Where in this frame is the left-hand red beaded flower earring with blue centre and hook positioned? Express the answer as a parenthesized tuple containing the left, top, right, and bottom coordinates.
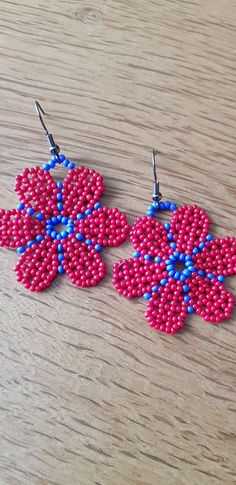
(0, 101, 129, 291)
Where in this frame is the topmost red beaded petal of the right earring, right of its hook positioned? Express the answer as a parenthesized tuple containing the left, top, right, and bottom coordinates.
(170, 205, 210, 253)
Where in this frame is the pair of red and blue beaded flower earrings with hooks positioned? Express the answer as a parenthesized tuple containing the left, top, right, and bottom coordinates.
(0, 101, 236, 334)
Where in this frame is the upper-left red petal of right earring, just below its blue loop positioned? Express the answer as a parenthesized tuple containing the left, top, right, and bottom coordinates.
(130, 216, 170, 257)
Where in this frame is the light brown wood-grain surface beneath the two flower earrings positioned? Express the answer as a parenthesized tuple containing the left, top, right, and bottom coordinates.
(0, 0, 236, 485)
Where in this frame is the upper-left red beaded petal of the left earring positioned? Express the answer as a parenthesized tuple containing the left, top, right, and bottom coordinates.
(15, 167, 58, 215)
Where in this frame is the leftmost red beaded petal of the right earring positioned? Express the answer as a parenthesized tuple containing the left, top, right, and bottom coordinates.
(112, 257, 164, 298)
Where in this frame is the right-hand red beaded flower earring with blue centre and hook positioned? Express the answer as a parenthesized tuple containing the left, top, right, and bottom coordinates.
(113, 151, 236, 334)
